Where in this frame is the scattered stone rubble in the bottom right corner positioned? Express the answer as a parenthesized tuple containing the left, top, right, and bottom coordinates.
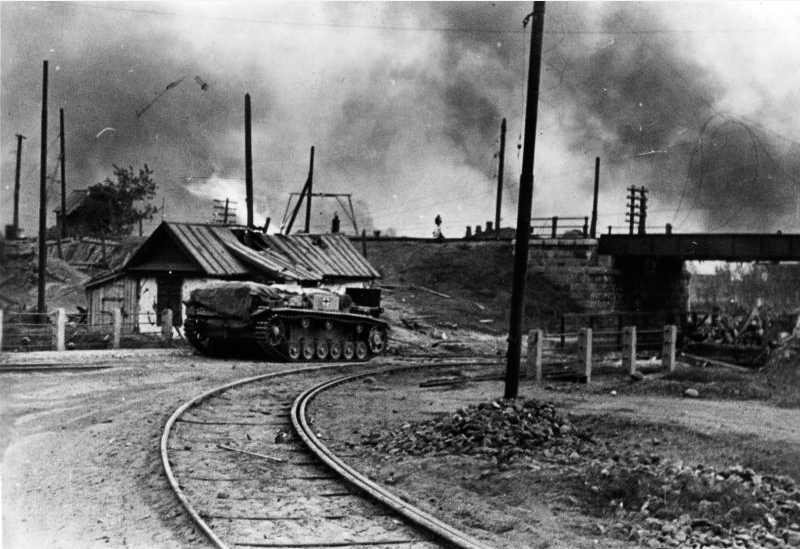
(579, 453, 800, 549)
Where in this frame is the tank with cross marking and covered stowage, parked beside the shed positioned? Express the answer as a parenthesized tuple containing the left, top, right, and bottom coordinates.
(184, 282, 389, 362)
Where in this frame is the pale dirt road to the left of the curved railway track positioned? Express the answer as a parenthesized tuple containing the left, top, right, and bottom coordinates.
(0, 350, 281, 549)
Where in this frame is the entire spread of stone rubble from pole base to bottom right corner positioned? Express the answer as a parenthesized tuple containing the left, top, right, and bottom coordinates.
(364, 400, 800, 549)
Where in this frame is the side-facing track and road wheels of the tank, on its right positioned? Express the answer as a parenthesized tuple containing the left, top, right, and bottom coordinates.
(255, 310, 387, 362)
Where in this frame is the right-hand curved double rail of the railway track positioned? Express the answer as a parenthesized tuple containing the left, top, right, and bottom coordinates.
(291, 364, 487, 549)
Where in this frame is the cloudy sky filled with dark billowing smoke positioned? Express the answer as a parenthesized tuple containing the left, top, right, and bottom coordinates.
(0, 2, 800, 237)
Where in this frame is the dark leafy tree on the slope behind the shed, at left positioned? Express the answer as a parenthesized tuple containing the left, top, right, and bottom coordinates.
(84, 164, 158, 237)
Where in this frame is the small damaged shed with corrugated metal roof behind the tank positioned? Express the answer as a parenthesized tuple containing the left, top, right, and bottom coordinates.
(86, 222, 380, 333)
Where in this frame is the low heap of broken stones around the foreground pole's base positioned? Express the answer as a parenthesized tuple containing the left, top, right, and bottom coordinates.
(364, 399, 588, 462)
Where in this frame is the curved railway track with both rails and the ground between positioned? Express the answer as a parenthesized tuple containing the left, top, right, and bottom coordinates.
(161, 362, 494, 549)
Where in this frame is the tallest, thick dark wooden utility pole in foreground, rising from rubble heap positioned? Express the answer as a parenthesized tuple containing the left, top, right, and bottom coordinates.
(505, 2, 545, 398)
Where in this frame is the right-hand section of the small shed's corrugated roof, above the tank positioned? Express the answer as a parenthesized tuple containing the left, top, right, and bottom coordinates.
(258, 234, 381, 279)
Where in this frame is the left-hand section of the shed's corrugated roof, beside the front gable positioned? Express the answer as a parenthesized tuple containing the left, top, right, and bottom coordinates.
(162, 222, 251, 276)
